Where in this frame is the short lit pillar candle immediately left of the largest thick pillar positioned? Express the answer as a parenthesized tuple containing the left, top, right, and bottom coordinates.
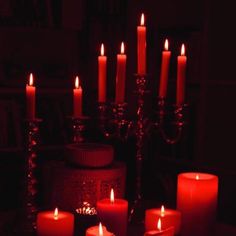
(145, 206, 181, 234)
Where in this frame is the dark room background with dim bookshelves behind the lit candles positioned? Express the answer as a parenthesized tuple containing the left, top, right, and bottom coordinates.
(0, 0, 236, 231)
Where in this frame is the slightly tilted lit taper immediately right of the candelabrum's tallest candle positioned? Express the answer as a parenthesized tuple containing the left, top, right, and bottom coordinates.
(159, 39, 171, 98)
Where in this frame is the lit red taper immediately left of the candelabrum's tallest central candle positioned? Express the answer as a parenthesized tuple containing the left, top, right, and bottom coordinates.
(115, 42, 126, 103)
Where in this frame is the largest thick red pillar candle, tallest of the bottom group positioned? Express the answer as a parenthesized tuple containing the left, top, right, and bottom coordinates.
(177, 172, 218, 236)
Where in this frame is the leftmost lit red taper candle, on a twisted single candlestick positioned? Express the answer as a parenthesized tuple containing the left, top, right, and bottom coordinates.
(26, 73, 36, 119)
